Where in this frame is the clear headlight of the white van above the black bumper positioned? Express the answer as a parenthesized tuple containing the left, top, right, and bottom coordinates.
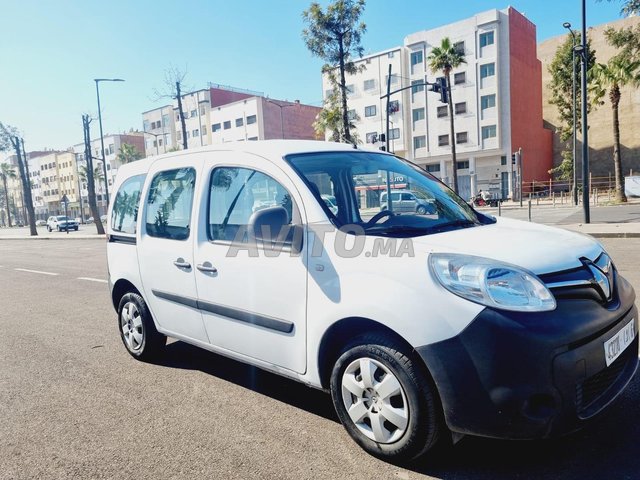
(429, 253, 556, 312)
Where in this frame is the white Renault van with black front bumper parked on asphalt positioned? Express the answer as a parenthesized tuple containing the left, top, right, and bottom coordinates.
(107, 141, 638, 460)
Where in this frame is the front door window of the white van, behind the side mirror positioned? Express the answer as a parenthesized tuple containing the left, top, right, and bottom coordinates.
(207, 167, 297, 242)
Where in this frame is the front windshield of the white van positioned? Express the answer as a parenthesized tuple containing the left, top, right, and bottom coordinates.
(286, 151, 495, 236)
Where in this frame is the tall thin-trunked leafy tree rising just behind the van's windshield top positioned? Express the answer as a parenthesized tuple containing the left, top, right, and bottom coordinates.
(302, 0, 367, 143)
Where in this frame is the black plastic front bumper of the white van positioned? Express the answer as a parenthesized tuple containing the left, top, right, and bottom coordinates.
(416, 274, 638, 439)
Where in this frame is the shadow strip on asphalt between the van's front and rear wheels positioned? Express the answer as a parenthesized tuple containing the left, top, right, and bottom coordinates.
(153, 341, 339, 422)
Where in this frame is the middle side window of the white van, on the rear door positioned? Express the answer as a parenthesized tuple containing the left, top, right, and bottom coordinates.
(145, 168, 196, 240)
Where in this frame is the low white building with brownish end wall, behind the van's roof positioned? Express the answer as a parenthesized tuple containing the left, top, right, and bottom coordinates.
(142, 84, 321, 156)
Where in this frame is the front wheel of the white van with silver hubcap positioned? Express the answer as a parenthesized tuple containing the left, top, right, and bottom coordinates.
(330, 335, 446, 462)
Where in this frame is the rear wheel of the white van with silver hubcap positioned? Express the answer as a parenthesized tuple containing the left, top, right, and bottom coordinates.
(118, 293, 167, 361)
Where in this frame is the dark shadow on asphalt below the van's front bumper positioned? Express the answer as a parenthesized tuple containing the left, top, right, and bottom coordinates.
(416, 368, 640, 480)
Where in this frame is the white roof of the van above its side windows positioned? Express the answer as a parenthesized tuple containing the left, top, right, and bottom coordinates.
(118, 140, 384, 177)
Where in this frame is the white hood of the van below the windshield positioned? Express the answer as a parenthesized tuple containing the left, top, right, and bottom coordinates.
(413, 217, 604, 275)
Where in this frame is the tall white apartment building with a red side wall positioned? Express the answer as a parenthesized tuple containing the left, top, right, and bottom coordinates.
(323, 7, 552, 198)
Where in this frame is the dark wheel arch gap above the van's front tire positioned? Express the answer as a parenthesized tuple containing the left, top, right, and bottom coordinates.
(318, 317, 431, 389)
